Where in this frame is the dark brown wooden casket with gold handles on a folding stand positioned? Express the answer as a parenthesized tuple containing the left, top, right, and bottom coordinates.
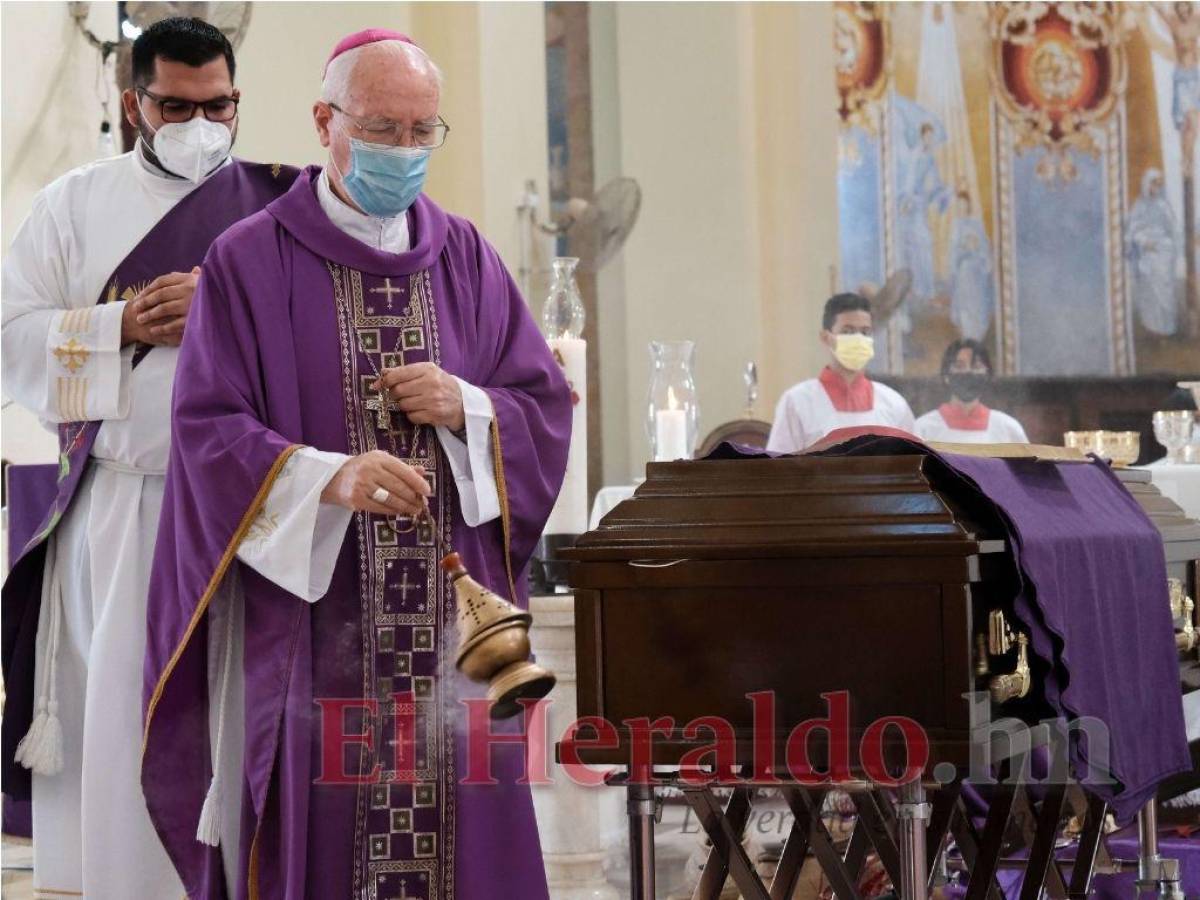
(564, 454, 1200, 776)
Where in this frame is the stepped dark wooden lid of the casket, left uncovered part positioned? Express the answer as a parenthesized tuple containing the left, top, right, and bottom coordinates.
(562, 452, 1004, 562)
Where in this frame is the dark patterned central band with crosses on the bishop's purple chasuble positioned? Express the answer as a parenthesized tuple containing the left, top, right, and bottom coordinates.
(319, 263, 457, 900)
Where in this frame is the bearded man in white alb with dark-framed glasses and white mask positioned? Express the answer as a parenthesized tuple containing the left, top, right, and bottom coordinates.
(2, 18, 295, 900)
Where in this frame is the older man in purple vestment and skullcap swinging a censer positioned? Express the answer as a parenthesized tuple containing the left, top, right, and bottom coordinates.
(142, 30, 571, 900)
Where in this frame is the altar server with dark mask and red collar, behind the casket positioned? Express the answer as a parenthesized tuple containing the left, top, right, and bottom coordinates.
(917, 338, 1030, 444)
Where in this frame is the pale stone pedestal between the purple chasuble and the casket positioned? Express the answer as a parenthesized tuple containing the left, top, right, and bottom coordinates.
(529, 594, 618, 900)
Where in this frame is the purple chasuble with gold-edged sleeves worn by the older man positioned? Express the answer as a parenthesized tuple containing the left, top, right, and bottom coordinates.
(142, 167, 571, 900)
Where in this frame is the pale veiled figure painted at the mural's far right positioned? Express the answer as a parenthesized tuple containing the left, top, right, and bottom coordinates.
(1126, 169, 1178, 335)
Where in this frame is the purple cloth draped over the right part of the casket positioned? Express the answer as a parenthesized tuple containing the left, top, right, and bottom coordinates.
(709, 434, 1192, 822)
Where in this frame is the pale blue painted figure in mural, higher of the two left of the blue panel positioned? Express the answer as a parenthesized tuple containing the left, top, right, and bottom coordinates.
(896, 120, 949, 321)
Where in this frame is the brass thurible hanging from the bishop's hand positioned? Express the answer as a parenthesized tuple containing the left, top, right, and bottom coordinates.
(442, 553, 556, 719)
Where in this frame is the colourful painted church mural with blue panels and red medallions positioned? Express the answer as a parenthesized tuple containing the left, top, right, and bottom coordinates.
(833, 2, 1200, 376)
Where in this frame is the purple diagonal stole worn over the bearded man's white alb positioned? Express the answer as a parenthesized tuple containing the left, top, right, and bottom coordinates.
(0, 160, 299, 798)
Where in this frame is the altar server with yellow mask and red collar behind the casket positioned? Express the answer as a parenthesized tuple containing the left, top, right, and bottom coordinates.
(767, 294, 913, 452)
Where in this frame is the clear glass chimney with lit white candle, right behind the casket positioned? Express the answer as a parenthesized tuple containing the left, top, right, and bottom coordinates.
(646, 341, 700, 462)
